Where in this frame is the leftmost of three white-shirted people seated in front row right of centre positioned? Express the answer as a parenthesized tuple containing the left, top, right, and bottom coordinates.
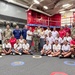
(41, 41, 51, 55)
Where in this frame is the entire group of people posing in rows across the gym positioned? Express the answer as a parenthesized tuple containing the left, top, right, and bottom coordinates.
(0, 23, 75, 57)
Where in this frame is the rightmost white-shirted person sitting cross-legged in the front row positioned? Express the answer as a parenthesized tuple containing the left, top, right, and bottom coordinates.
(62, 40, 71, 57)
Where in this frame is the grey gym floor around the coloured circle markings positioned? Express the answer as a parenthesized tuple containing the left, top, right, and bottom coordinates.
(0, 52, 75, 75)
